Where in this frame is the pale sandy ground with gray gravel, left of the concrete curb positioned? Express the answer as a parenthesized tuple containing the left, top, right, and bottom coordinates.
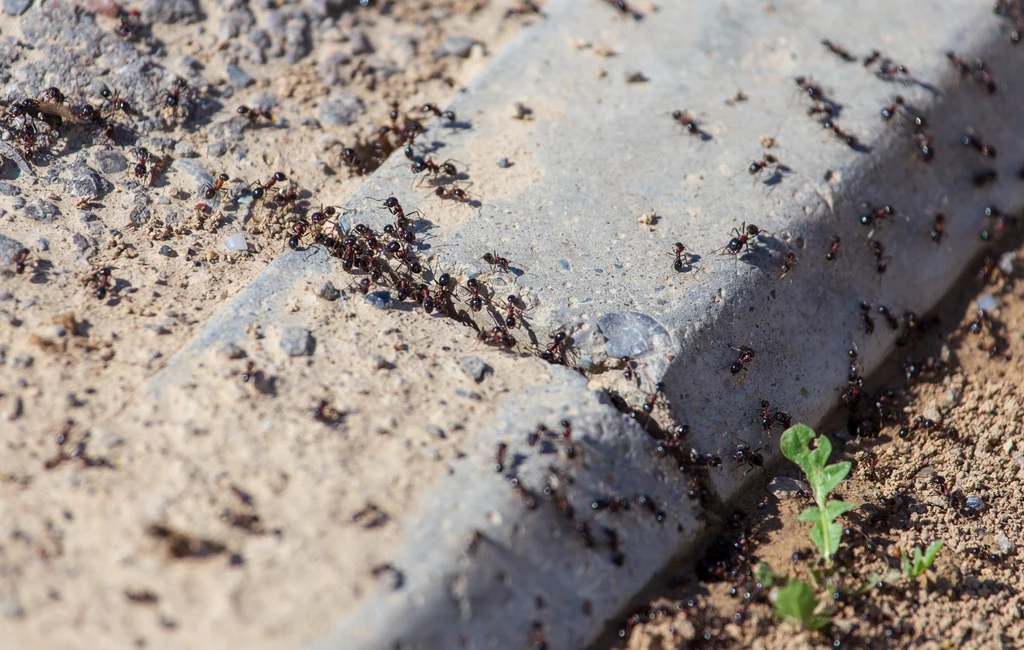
(0, 0, 545, 648)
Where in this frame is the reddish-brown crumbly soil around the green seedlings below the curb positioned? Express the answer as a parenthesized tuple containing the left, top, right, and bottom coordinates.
(597, 240, 1024, 650)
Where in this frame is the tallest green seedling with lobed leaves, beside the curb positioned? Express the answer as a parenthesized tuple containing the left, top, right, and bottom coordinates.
(781, 425, 855, 560)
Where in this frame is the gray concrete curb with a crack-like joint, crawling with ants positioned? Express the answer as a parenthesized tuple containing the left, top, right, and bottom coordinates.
(134, 0, 1024, 648)
